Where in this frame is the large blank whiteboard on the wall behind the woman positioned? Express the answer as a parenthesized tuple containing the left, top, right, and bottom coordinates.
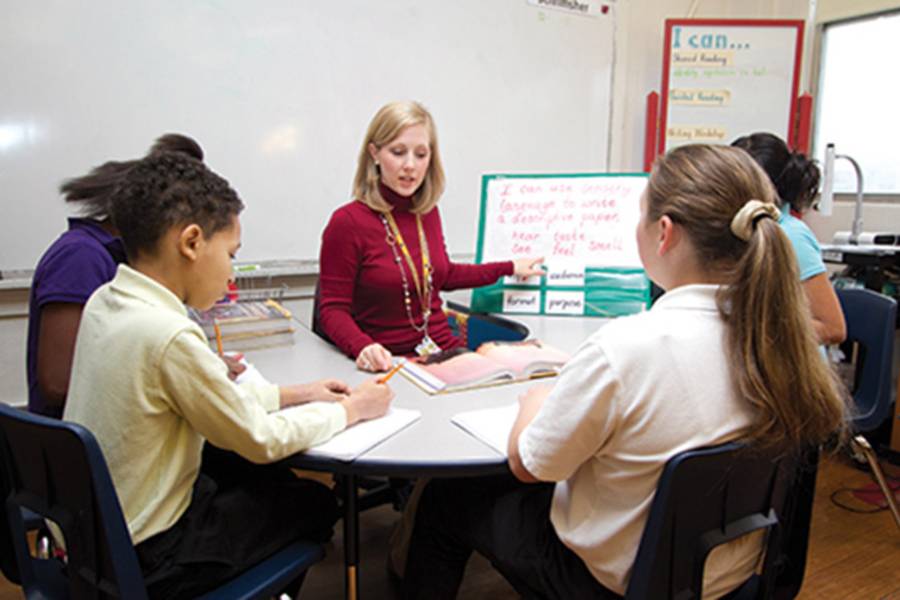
(0, 0, 615, 269)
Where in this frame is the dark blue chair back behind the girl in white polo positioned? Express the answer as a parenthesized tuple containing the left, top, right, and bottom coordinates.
(625, 443, 815, 600)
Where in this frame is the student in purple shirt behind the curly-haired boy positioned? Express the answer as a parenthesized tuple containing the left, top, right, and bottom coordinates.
(26, 134, 203, 418)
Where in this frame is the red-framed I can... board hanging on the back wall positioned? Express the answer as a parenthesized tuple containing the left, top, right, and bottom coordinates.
(659, 19, 803, 153)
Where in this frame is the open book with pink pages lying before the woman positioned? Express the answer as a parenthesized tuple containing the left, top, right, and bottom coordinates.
(400, 340, 569, 394)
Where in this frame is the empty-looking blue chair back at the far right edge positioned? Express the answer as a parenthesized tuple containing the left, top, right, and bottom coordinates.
(837, 289, 897, 431)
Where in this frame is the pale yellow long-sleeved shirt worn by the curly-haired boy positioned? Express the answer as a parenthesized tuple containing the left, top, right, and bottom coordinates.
(63, 265, 347, 544)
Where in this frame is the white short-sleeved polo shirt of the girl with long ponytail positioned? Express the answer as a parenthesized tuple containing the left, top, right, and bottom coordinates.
(519, 285, 762, 597)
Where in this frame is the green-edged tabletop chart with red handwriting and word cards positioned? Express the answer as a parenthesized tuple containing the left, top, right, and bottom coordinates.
(472, 173, 650, 317)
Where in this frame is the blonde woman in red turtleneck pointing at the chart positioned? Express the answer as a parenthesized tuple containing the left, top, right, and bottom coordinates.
(319, 101, 543, 371)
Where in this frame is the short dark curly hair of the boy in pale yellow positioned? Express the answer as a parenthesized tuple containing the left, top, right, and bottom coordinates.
(110, 152, 244, 260)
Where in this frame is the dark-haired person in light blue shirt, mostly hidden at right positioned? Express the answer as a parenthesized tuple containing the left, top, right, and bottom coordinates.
(731, 133, 847, 344)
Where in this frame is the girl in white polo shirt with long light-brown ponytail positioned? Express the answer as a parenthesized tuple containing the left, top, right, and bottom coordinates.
(404, 145, 846, 598)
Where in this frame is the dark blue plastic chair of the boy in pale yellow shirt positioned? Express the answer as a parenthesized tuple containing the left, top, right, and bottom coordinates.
(0, 404, 324, 600)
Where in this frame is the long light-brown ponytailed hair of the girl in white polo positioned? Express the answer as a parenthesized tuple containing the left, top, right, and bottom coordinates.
(647, 145, 848, 447)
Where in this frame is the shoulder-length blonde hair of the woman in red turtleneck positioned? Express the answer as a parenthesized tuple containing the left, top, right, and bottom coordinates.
(353, 100, 444, 214)
